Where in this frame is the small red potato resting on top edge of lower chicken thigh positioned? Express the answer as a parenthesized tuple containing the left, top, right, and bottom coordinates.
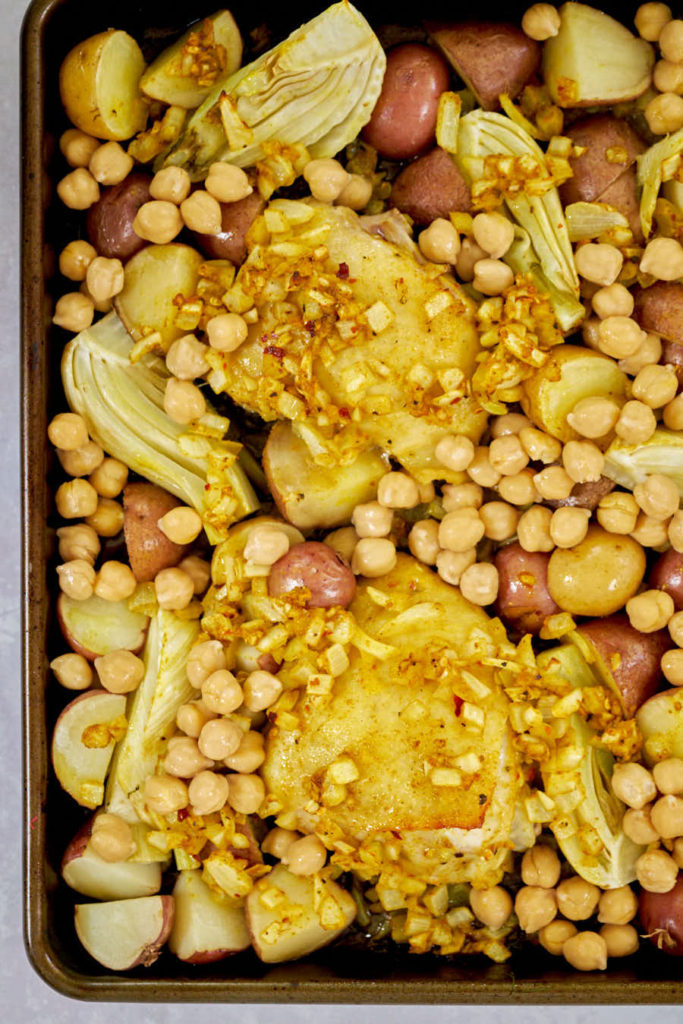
(268, 541, 355, 608)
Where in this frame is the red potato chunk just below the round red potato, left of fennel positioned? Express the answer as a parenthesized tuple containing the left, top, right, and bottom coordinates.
(391, 146, 472, 224)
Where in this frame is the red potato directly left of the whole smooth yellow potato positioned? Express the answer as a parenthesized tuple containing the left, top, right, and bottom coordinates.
(494, 541, 560, 633)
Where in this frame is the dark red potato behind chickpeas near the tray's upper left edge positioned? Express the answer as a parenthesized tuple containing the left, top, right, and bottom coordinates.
(87, 171, 152, 261)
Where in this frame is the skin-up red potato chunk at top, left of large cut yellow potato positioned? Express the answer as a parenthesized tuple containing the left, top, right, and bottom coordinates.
(426, 22, 541, 111)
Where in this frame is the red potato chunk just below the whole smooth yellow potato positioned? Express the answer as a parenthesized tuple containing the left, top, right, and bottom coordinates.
(578, 614, 671, 717)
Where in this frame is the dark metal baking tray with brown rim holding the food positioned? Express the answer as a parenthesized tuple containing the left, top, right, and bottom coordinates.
(22, 0, 683, 1004)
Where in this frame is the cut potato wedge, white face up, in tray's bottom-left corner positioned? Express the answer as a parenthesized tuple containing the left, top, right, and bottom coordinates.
(74, 896, 174, 971)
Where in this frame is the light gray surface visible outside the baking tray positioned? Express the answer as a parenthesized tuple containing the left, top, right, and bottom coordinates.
(0, 0, 683, 1024)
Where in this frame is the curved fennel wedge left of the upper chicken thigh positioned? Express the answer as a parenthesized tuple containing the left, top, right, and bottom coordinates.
(61, 312, 258, 544)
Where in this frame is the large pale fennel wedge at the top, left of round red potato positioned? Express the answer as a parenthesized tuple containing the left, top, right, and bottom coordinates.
(166, 0, 386, 180)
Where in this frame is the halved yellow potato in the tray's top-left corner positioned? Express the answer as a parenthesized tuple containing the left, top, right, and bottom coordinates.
(59, 29, 147, 139)
